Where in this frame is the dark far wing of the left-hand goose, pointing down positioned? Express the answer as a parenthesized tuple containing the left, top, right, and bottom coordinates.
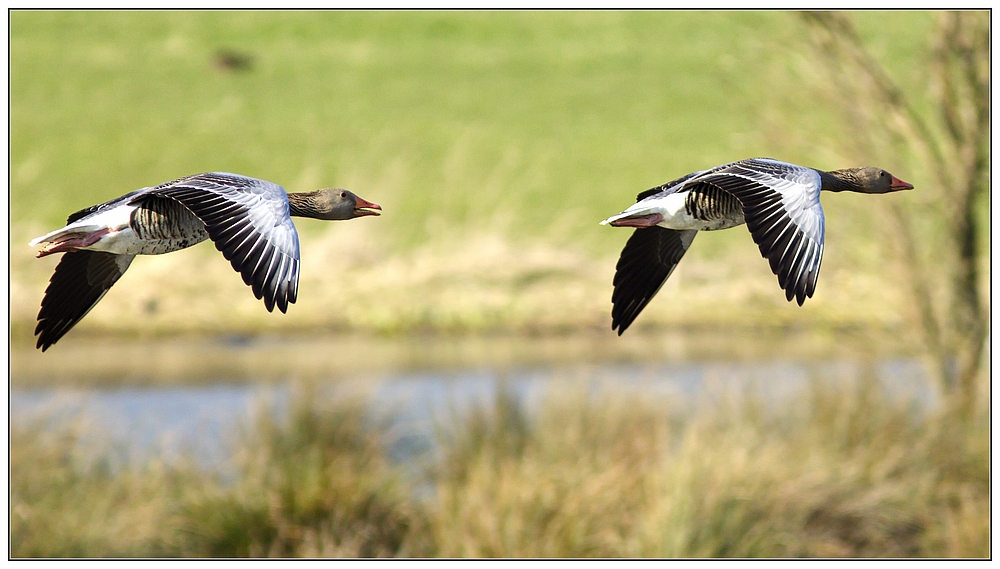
(35, 251, 135, 352)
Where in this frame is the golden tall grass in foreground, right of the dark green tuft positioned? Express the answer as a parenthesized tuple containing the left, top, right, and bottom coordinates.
(420, 374, 989, 557)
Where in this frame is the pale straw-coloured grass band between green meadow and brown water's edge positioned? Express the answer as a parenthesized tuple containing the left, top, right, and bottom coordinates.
(10, 220, 913, 353)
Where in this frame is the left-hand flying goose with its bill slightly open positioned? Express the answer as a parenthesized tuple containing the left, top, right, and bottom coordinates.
(29, 172, 382, 352)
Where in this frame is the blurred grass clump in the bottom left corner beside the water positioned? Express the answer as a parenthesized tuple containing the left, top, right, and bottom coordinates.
(10, 408, 197, 557)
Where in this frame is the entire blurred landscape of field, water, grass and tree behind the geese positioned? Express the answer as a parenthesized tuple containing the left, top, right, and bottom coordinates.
(9, 11, 990, 557)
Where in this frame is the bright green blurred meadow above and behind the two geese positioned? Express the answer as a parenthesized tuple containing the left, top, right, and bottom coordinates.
(11, 12, 930, 243)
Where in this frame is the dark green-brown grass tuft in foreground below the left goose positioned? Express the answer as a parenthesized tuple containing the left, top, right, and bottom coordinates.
(178, 388, 422, 557)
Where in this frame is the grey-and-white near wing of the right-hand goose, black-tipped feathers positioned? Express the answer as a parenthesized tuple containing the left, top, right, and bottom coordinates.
(698, 158, 825, 306)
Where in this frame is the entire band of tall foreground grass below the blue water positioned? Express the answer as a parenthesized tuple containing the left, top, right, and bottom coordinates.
(11, 374, 990, 557)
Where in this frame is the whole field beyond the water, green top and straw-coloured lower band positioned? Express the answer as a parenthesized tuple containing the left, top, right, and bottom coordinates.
(10, 12, 944, 343)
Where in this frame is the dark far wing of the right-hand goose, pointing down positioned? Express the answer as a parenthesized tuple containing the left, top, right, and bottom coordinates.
(611, 226, 698, 336)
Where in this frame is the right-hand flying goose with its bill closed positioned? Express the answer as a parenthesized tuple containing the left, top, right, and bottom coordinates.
(601, 158, 913, 336)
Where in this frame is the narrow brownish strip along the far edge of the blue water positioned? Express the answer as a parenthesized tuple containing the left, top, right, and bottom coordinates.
(10, 327, 917, 390)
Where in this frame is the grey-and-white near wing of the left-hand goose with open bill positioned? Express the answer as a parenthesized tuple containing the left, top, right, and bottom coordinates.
(149, 172, 299, 312)
